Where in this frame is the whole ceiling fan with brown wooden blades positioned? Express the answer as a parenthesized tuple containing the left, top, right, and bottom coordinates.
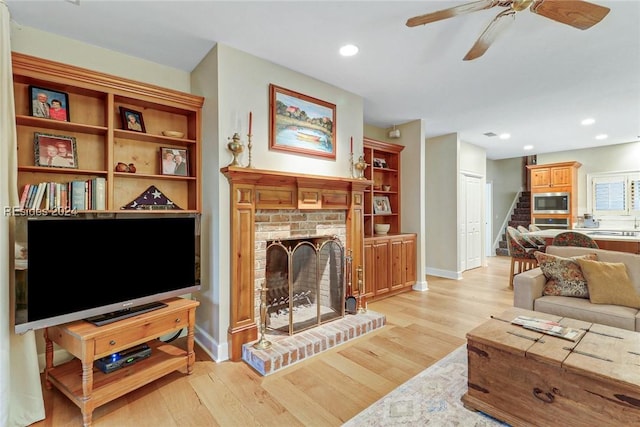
(407, 0, 610, 61)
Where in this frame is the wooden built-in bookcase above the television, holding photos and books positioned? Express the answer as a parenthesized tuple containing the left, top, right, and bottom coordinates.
(12, 52, 204, 213)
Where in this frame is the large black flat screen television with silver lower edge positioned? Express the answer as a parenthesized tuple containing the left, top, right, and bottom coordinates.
(14, 213, 200, 333)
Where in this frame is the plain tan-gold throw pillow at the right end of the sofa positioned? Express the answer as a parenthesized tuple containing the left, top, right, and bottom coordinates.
(577, 259, 640, 309)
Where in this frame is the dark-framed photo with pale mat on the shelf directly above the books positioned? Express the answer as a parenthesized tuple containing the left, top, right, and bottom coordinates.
(33, 132, 78, 169)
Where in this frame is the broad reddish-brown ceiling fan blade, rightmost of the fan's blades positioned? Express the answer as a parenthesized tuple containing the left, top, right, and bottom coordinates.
(529, 0, 610, 30)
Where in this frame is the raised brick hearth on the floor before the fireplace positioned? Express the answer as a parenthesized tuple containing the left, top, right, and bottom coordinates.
(242, 310, 386, 376)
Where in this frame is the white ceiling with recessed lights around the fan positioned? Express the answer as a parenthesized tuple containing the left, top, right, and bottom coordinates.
(5, 0, 640, 159)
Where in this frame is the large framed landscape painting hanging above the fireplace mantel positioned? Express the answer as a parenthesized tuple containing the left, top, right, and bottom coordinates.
(269, 84, 336, 160)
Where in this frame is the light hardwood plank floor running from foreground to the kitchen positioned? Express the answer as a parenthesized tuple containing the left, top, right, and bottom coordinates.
(33, 257, 513, 427)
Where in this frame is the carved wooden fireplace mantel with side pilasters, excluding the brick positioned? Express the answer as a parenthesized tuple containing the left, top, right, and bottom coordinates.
(220, 166, 372, 361)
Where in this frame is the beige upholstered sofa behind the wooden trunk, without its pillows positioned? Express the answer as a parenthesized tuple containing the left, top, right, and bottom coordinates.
(513, 246, 640, 332)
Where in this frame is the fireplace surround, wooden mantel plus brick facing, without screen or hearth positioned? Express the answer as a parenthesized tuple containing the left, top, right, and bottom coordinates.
(221, 166, 371, 361)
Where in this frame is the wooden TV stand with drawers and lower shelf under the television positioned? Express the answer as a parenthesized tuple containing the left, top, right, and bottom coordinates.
(44, 298, 200, 426)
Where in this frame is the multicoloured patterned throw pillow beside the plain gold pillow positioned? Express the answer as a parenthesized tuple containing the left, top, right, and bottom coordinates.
(534, 251, 598, 298)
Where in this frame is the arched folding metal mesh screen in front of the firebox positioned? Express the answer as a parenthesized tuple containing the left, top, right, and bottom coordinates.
(266, 236, 345, 335)
